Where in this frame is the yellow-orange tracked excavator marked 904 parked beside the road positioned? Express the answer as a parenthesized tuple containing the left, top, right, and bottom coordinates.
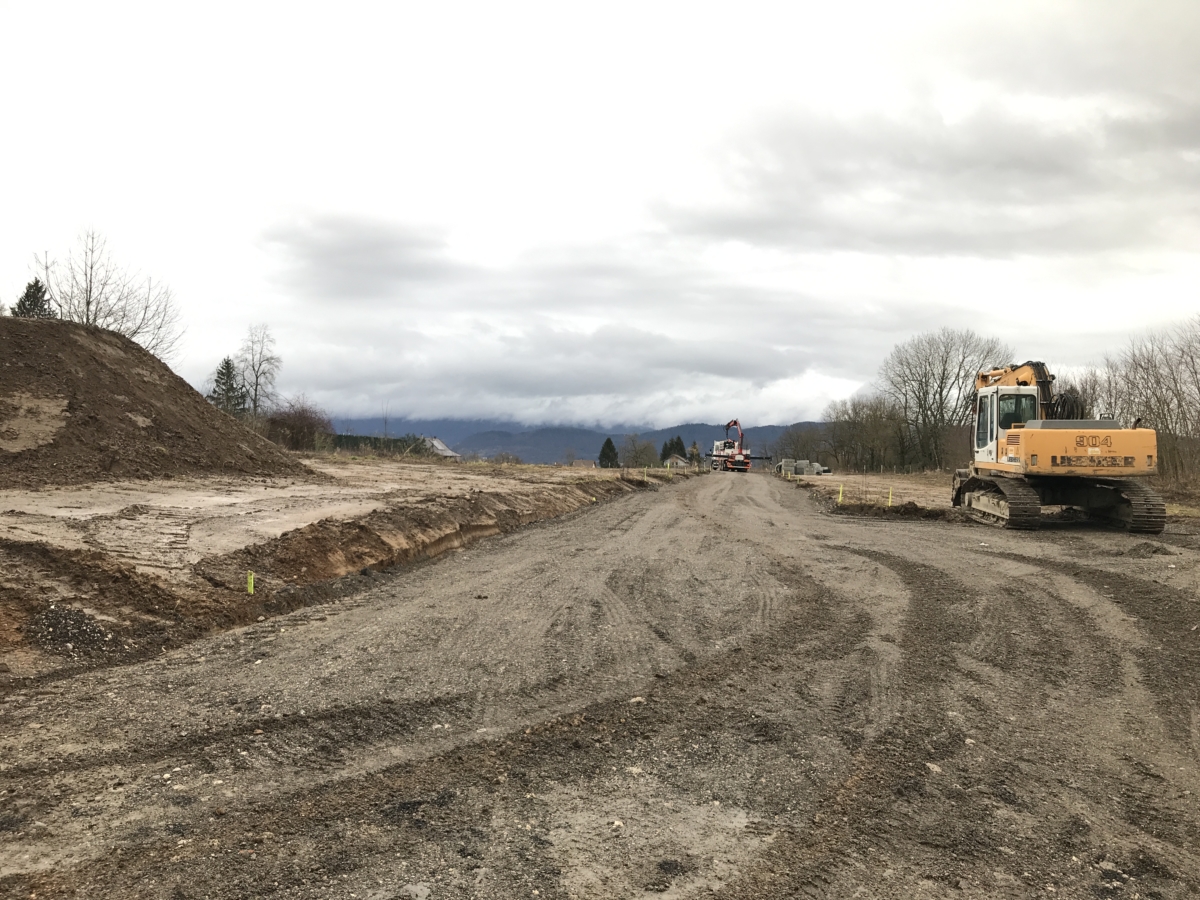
(954, 362, 1166, 534)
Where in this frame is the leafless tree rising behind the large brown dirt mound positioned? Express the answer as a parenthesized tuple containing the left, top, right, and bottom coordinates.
(37, 229, 184, 360)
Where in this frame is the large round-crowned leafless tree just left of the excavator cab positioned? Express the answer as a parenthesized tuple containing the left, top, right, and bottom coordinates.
(880, 328, 1013, 468)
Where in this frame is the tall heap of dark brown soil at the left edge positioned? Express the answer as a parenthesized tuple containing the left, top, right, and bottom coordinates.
(0, 317, 306, 488)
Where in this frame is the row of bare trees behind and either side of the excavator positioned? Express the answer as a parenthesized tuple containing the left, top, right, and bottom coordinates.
(773, 316, 1200, 480)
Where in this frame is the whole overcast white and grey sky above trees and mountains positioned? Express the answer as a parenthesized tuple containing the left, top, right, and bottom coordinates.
(0, 0, 1200, 426)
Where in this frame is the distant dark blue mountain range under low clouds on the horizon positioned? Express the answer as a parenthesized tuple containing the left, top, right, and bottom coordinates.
(334, 418, 815, 463)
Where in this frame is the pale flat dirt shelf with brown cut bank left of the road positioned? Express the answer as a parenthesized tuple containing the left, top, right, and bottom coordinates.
(0, 461, 681, 685)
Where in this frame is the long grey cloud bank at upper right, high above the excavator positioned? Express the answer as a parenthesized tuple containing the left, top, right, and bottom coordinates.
(664, 102, 1200, 257)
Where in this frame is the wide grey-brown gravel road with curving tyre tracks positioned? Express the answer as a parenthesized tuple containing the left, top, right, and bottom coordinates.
(0, 475, 1200, 900)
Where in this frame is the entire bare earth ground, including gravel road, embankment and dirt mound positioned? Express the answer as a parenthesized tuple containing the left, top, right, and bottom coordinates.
(0, 319, 1200, 900)
